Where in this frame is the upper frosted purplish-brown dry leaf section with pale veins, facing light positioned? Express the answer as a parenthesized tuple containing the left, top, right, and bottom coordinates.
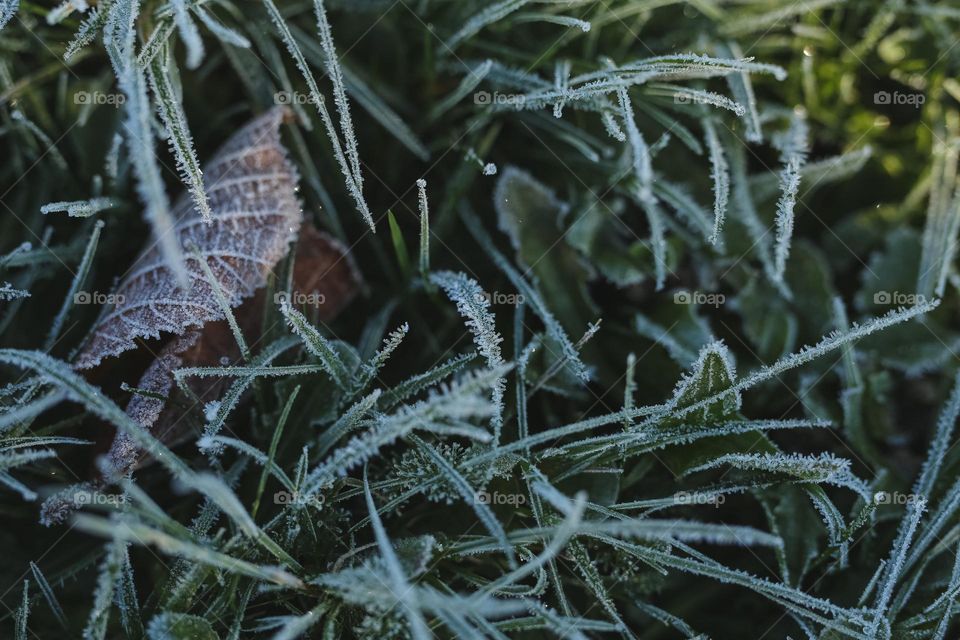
(76, 108, 303, 369)
